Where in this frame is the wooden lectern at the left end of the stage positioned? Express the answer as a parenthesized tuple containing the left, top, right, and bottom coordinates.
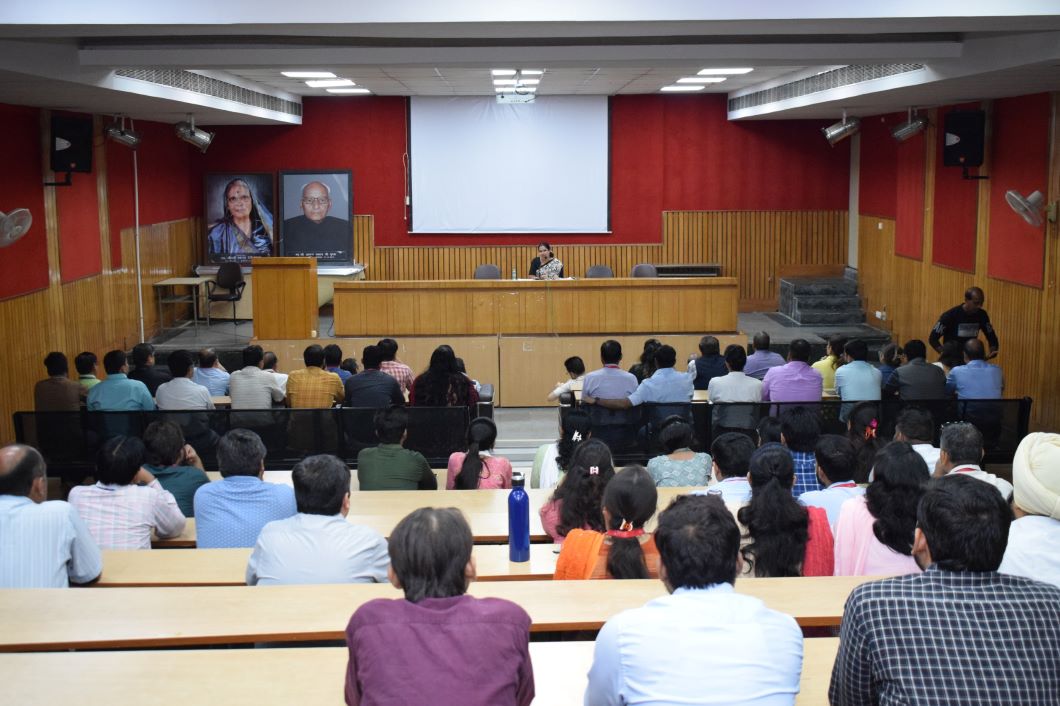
(250, 258, 318, 339)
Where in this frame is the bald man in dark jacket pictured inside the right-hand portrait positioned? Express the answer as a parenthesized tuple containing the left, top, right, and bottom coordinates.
(281, 181, 353, 262)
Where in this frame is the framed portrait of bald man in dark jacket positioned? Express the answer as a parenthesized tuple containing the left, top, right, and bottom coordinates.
(280, 170, 353, 263)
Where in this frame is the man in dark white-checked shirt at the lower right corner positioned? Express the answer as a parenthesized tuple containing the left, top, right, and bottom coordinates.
(826, 474, 1060, 706)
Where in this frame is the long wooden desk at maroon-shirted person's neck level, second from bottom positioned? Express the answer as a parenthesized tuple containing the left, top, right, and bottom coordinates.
(0, 577, 869, 652)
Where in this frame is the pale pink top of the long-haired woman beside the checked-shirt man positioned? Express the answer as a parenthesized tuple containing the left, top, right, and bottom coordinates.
(835, 495, 920, 576)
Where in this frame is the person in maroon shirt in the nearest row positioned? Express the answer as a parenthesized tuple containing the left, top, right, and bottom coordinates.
(346, 508, 534, 706)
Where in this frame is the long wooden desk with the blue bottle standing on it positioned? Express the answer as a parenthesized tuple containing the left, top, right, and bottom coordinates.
(102, 544, 558, 587)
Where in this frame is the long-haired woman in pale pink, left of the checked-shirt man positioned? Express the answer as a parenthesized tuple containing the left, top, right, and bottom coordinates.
(835, 441, 929, 576)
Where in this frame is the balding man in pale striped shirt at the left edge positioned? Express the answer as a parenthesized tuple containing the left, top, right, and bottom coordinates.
(0, 444, 103, 588)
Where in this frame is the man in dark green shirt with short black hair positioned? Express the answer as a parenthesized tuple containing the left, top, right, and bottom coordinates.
(357, 407, 438, 491)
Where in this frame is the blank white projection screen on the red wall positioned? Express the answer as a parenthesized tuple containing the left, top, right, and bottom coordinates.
(409, 95, 608, 233)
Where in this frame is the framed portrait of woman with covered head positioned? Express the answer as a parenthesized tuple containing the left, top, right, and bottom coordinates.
(202, 173, 276, 264)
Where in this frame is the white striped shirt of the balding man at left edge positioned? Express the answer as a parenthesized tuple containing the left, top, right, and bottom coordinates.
(0, 495, 103, 588)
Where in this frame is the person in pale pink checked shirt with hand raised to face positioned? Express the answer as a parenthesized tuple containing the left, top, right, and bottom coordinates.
(70, 434, 186, 549)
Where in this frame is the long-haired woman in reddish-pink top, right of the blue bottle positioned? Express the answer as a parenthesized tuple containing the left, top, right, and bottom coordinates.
(538, 439, 615, 544)
